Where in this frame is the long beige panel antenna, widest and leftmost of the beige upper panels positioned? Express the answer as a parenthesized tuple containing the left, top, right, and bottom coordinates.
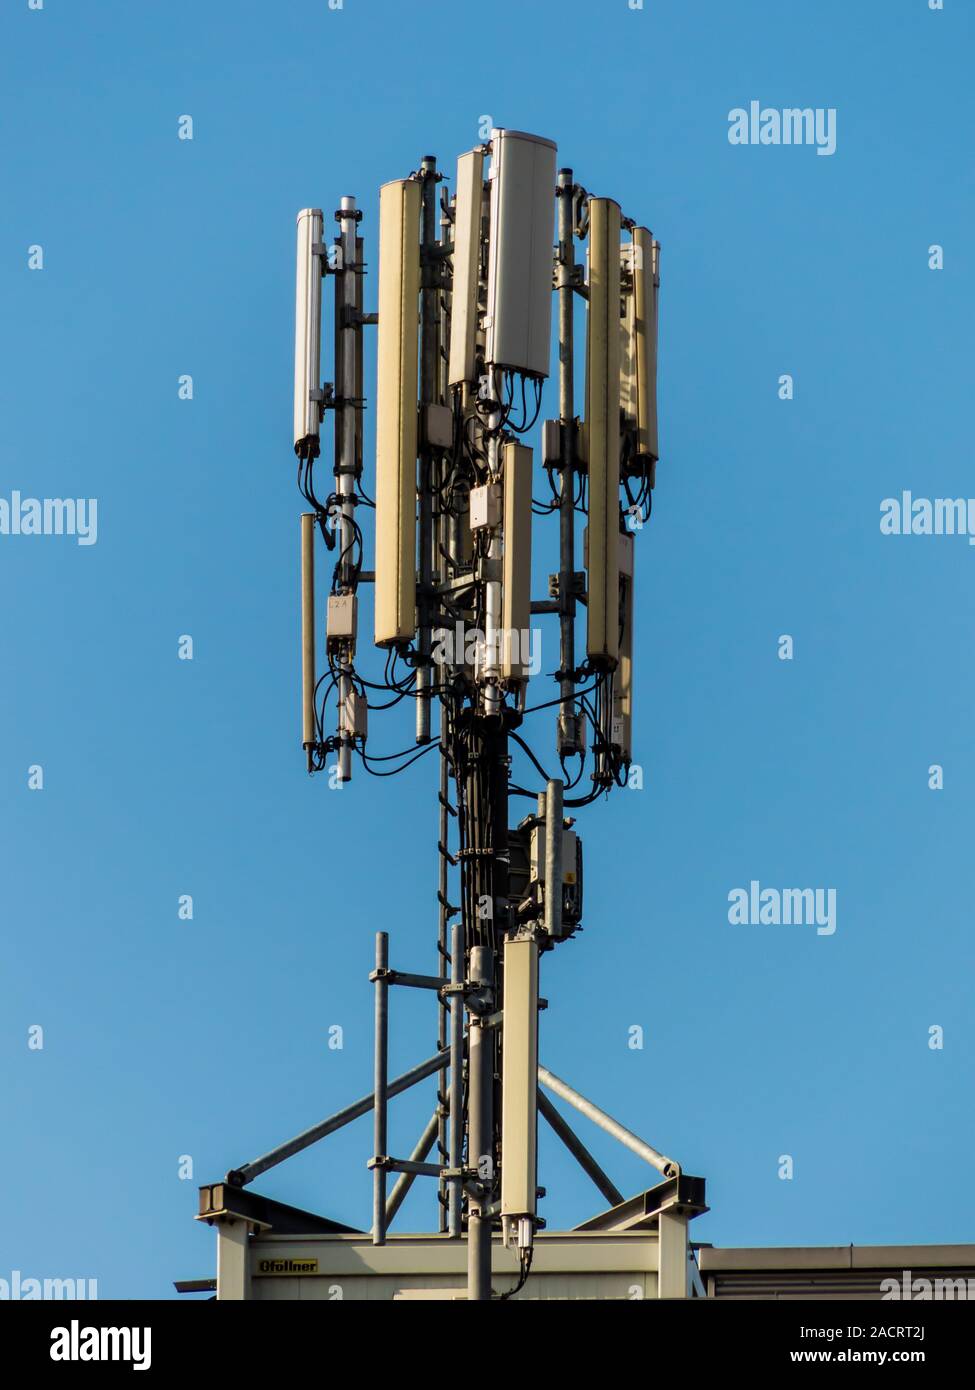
(376, 179, 420, 646)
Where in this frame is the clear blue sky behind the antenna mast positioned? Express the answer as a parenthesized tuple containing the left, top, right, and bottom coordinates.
(0, 0, 975, 1297)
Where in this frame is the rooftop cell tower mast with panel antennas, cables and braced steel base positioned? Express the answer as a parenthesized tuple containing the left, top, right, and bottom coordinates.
(200, 129, 705, 1300)
